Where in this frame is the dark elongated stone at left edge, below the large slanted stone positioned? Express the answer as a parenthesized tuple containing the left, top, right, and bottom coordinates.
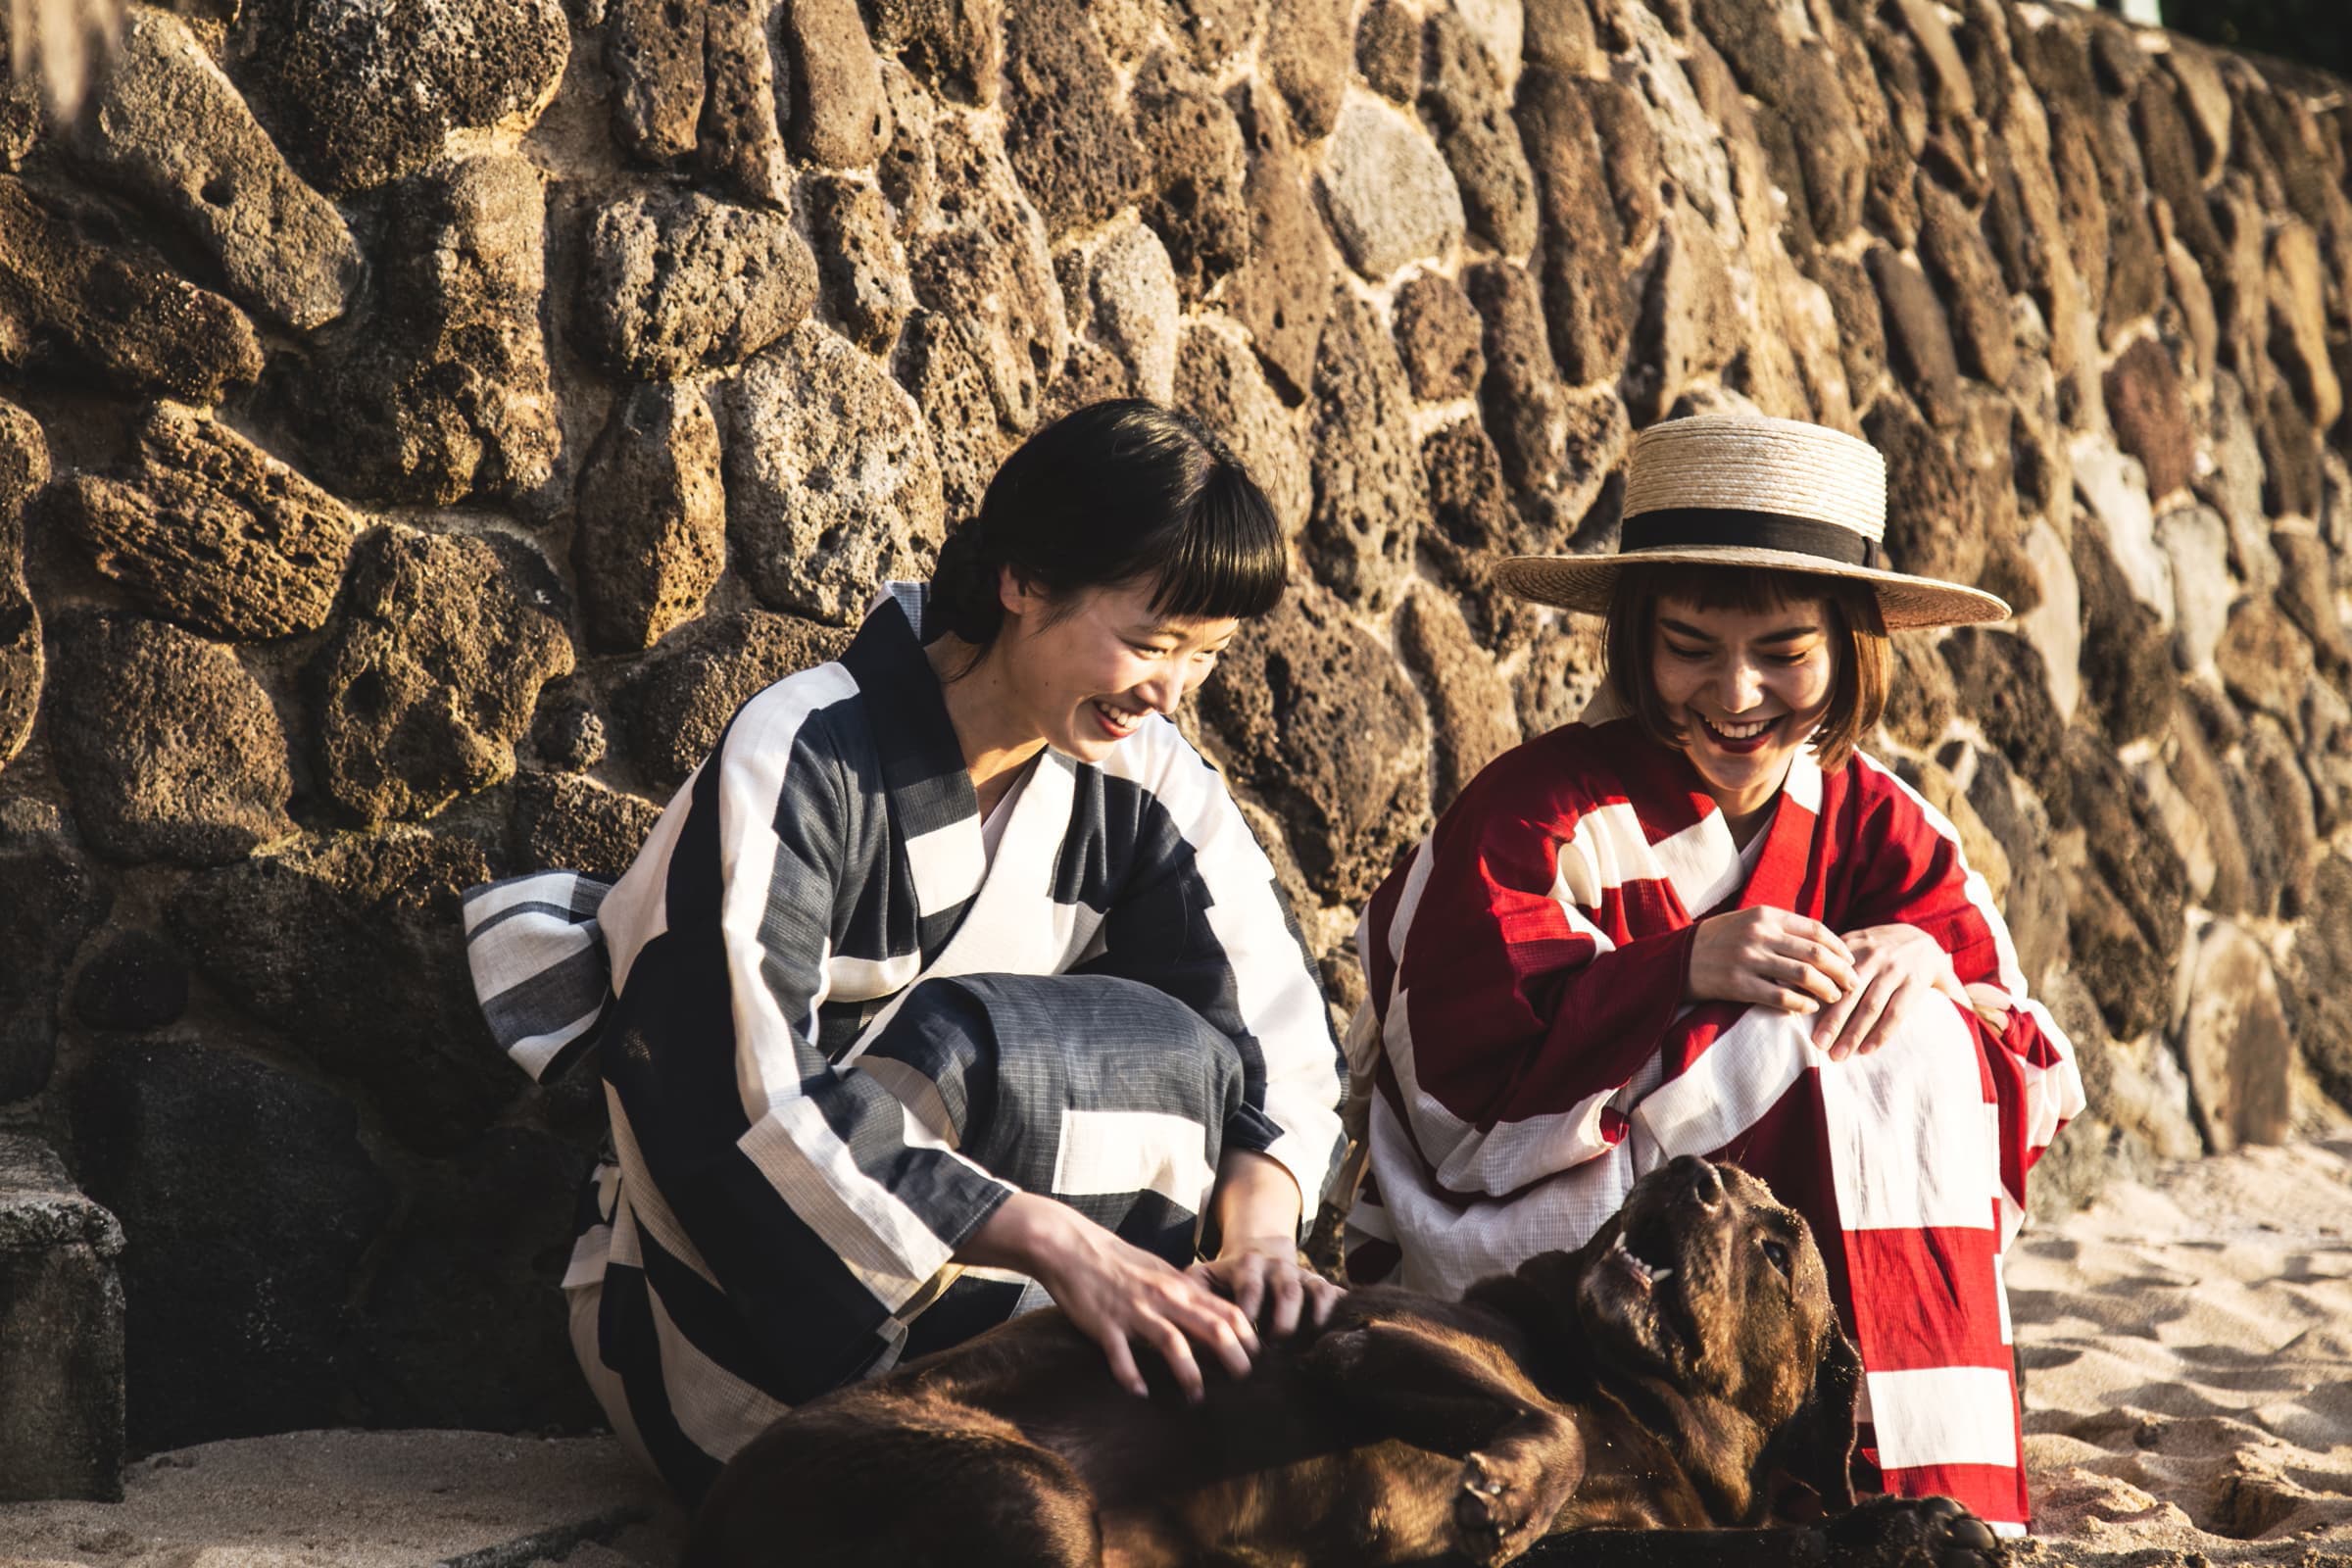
(0, 176, 261, 405)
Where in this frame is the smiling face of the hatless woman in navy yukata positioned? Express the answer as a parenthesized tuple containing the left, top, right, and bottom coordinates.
(990, 571, 1242, 761)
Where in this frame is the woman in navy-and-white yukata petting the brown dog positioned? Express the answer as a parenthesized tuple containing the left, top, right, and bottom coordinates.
(466, 402, 1343, 1499)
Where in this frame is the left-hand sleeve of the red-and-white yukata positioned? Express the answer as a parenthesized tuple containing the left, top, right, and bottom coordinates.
(1357, 736, 1695, 1199)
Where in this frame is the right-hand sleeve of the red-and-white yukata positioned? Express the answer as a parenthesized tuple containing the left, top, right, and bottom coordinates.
(1830, 755, 2083, 1208)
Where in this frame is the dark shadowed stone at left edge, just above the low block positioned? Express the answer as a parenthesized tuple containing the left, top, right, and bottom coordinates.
(0, 800, 113, 1104)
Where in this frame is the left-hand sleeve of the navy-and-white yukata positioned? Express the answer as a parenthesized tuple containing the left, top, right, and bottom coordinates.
(600, 665, 1011, 1392)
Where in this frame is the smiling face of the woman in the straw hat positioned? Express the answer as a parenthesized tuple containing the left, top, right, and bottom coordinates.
(1648, 600, 1839, 827)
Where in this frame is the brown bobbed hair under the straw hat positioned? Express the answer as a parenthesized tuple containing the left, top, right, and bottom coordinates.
(1601, 562, 1893, 773)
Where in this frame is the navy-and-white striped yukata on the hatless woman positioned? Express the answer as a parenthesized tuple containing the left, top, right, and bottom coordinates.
(466, 585, 1343, 1499)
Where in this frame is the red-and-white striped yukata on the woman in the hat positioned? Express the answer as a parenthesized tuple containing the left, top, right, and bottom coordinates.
(1348, 719, 2083, 1535)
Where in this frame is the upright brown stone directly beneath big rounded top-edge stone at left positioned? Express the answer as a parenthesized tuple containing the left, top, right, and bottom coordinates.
(287, 155, 563, 506)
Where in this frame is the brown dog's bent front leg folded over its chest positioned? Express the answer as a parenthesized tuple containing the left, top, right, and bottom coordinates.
(1305, 1321, 1586, 1566)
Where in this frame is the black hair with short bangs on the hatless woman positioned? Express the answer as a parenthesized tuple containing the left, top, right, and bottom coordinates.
(927, 397, 1289, 647)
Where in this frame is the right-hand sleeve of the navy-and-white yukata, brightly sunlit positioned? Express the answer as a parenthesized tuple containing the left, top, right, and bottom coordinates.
(1080, 724, 1346, 1227)
